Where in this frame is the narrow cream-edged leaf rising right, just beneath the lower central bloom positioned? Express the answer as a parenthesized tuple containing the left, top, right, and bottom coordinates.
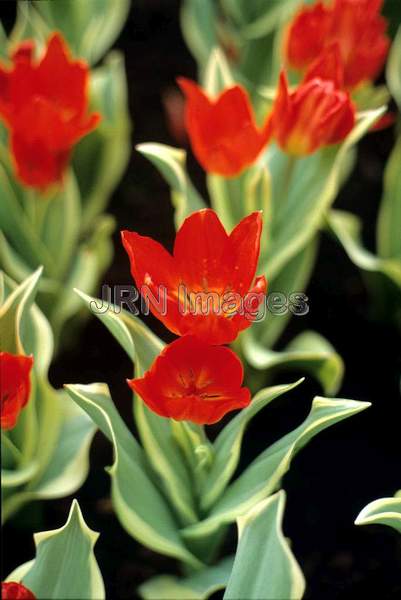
(201, 379, 303, 512)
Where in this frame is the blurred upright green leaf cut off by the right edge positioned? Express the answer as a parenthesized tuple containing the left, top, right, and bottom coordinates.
(377, 135, 401, 263)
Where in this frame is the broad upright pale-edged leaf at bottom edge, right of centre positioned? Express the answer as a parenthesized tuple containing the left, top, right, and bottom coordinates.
(224, 490, 305, 600)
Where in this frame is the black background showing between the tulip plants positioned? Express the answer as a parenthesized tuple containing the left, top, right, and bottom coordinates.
(0, 0, 401, 600)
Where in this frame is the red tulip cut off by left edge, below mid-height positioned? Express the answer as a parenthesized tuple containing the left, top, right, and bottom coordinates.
(0, 352, 33, 429)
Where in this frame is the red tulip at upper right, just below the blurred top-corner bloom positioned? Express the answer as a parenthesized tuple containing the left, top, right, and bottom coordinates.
(271, 73, 355, 156)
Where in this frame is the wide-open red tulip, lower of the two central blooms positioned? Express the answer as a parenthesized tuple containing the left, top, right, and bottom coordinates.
(128, 336, 251, 425)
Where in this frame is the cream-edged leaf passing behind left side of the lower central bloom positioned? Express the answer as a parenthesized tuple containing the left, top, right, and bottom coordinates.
(76, 290, 200, 524)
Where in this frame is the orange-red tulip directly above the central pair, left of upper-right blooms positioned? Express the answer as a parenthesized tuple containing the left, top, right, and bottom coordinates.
(178, 78, 270, 177)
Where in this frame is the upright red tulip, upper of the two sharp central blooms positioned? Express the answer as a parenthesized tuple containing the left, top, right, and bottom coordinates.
(122, 209, 267, 344)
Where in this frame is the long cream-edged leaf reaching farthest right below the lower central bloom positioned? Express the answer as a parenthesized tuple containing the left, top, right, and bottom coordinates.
(182, 396, 370, 540)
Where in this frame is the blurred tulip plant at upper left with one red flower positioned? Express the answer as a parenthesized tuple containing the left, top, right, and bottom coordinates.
(0, 0, 130, 343)
